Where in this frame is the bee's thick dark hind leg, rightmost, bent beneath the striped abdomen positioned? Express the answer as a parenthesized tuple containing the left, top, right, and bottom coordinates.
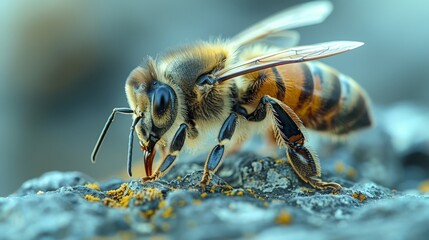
(246, 96, 341, 190)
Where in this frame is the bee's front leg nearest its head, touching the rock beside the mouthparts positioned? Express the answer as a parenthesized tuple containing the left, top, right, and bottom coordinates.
(142, 123, 187, 182)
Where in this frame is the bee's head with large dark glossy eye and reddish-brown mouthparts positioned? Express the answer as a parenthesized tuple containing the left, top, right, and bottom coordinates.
(125, 59, 178, 174)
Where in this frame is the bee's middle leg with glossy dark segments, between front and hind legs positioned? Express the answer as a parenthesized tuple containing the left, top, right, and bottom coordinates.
(200, 112, 237, 189)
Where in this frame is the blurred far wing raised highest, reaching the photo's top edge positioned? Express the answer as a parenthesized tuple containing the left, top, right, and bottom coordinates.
(232, 1, 333, 46)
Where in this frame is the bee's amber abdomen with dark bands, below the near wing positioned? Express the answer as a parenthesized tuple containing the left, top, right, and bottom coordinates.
(243, 62, 371, 135)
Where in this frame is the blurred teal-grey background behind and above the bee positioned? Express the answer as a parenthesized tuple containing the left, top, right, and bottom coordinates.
(0, 0, 429, 196)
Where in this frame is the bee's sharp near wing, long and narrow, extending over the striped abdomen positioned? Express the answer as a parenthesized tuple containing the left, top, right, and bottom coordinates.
(216, 41, 363, 82)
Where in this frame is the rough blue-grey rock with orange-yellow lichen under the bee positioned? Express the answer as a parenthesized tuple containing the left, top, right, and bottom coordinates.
(0, 103, 429, 240)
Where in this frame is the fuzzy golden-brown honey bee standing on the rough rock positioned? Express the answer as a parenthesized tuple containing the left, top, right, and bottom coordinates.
(91, 1, 371, 190)
